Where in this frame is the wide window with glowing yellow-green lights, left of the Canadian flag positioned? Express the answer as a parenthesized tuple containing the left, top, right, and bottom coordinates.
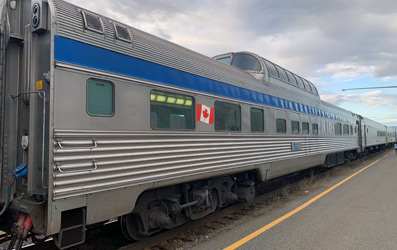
(150, 90, 195, 130)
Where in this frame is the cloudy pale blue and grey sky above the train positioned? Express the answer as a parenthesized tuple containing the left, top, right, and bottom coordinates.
(67, 0, 397, 125)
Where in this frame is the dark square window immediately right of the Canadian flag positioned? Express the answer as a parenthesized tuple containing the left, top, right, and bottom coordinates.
(215, 101, 241, 131)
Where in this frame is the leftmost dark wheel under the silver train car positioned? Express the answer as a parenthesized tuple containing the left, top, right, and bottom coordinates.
(119, 214, 146, 241)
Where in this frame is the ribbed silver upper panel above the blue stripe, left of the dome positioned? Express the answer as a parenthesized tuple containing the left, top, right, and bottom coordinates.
(53, 0, 257, 87)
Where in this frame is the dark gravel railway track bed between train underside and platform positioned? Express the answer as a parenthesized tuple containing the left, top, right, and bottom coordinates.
(0, 151, 383, 250)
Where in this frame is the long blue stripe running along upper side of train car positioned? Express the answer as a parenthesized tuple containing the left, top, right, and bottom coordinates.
(54, 36, 344, 121)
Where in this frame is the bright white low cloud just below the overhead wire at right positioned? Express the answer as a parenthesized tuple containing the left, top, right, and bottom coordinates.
(321, 90, 397, 111)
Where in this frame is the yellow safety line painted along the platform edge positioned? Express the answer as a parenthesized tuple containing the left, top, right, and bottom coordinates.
(223, 155, 388, 250)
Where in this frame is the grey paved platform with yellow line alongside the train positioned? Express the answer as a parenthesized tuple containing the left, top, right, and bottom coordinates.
(193, 150, 397, 250)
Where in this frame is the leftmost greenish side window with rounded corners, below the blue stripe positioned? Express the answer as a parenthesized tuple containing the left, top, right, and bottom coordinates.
(87, 79, 114, 116)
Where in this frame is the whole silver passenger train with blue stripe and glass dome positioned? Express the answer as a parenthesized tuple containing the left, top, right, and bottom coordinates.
(0, 0, 396, 249)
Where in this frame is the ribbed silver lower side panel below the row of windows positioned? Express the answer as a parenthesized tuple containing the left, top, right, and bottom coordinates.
(53, 131, 356, 199)
